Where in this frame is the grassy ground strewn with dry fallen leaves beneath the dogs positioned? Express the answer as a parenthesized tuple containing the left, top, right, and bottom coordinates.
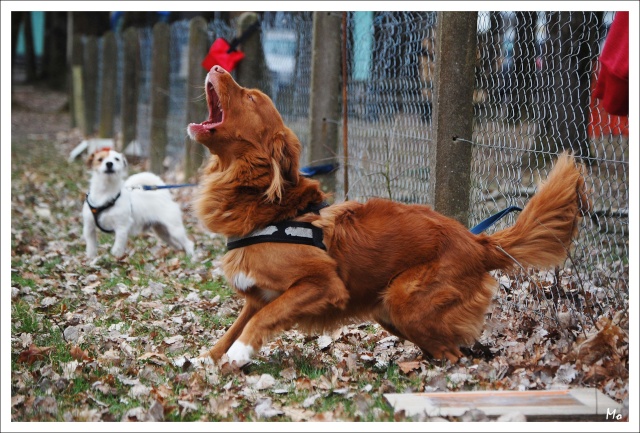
(8, 83, 629, 422)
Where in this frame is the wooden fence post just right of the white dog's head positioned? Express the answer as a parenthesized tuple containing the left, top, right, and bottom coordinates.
(120, 27, 140, 152)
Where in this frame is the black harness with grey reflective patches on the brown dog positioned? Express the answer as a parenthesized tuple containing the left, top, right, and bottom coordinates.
(227, 202, 329, 251)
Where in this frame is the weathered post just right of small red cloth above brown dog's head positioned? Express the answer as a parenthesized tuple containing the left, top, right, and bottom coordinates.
(236, 12, 271, 95)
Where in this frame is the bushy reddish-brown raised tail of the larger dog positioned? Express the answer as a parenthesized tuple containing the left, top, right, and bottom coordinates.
(487, 152, 590, 270)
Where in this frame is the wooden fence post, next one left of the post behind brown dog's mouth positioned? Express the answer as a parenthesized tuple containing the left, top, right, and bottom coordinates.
(149, 22, 171, 174)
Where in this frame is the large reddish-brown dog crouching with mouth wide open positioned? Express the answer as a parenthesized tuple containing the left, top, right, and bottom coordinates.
(188, 66, 587, 365)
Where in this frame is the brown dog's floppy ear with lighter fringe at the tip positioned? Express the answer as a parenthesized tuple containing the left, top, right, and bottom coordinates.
(266, 128, 300, 202)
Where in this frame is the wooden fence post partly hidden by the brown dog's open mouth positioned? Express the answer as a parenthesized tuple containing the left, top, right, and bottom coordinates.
(184, 17, 210, 179)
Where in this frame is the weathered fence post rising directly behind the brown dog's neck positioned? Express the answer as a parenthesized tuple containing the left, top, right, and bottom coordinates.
(307, 11, 346, 192)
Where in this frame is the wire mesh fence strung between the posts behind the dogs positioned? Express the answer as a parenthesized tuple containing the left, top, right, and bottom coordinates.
(86, 12, 629, 323)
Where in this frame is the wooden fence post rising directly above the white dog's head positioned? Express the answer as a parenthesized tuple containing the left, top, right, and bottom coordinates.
(98, 31, 118, 138)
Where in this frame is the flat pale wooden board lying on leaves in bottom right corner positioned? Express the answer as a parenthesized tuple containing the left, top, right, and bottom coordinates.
(384, 388, 622, 421)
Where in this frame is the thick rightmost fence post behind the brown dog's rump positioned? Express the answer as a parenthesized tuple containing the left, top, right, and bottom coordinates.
(429, 12, 477, 225)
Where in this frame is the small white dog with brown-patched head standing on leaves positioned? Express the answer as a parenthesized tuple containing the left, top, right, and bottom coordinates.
(82, 148, 193, 257)
